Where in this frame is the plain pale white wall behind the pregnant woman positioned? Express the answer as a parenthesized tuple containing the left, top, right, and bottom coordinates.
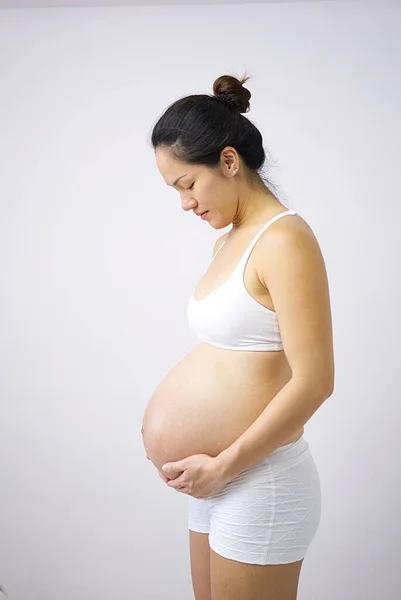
(0, 0, 401, 600)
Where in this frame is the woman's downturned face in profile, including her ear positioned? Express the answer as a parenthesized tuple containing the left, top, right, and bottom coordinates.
(156, 148, 239, 229)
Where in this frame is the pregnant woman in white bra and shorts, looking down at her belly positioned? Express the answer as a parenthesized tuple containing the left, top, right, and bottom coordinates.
(142, 75, 334, 600)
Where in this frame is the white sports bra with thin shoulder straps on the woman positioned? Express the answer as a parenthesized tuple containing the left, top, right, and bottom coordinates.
(187, 209, 298, 352)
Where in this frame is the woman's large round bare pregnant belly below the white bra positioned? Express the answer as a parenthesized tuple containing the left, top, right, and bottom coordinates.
(142, 344, 289, 470)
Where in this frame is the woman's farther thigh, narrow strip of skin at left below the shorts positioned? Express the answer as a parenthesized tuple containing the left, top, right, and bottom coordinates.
(189, 530, 211, 600)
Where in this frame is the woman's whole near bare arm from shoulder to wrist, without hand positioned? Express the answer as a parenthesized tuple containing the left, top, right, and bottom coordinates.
(216, 222, 334, 479)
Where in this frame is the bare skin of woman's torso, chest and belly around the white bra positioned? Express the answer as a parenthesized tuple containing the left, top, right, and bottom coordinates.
(142, 210, 306, 469)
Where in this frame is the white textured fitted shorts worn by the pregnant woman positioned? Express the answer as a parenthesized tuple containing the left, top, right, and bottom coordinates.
(188, 437, 321, 565)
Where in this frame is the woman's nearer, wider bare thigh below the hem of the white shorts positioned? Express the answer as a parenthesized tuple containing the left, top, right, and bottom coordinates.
(210, 550, 303, 600)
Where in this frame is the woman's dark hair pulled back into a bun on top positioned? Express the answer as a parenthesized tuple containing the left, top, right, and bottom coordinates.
(151, 75, 273, 195)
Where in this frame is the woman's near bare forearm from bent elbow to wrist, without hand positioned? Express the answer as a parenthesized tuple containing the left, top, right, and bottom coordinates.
(216, 379, 331, 481)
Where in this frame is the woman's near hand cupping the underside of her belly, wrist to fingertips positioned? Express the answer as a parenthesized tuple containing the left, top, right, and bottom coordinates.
(162, 454, 229, 498)
